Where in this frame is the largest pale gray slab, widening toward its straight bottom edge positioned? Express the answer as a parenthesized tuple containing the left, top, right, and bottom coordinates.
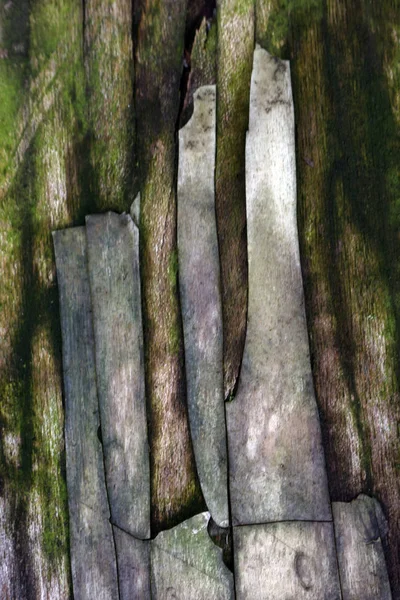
(226, 49, 331, 524)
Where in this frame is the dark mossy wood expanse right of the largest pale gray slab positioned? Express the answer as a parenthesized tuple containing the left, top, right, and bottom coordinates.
(256, 0, 400, 600)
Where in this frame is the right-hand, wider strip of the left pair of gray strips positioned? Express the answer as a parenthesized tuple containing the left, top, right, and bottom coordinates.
(86, 212, 150, 539)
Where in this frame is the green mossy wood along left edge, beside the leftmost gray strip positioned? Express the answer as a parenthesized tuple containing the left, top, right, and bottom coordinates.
(0, 0, 87, 600)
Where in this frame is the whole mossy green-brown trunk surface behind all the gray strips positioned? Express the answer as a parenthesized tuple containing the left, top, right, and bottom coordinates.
(0, 0, 400, 600)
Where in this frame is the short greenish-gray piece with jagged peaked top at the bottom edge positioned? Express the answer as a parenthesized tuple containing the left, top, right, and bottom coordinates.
(151, 513, 234, 600)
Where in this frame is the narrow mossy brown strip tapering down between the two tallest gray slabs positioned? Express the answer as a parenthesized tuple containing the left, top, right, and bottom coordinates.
(215, 0, 254, 398)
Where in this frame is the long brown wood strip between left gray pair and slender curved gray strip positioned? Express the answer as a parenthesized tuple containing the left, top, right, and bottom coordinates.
(136, 0, 204, 532)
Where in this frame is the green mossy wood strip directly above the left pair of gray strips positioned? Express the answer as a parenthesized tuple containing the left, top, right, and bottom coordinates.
(83, 0, 135, 211)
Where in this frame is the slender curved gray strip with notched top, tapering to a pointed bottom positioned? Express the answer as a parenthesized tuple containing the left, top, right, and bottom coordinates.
(178, 85, 229, 527)
